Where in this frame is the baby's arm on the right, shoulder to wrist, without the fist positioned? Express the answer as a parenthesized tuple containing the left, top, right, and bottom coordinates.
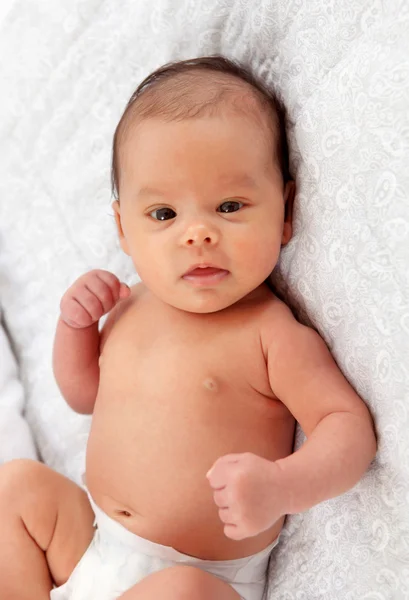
(268, 307, 376, 513)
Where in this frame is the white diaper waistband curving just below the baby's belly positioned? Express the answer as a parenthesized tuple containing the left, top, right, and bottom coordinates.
(87, 491, 279, 578)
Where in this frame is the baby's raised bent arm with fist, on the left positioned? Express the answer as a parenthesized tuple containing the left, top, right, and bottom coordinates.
(53, 270, 130, 414)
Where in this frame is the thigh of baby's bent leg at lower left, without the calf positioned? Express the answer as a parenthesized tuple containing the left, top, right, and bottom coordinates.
(0, 460, 94, 585)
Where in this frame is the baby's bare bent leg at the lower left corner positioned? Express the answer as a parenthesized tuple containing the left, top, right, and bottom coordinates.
(0, 460, 94, 600)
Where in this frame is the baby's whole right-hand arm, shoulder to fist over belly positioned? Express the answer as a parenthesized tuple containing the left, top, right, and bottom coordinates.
(206, 303, 376, 540)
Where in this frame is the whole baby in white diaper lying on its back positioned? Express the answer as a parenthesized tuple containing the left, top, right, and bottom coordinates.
(0, 57, 376, 600)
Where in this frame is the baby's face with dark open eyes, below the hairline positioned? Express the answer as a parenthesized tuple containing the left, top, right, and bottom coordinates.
(114, 115, 286, 313)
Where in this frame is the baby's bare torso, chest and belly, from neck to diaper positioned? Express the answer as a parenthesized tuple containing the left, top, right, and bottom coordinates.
(87, 285, 294, 560)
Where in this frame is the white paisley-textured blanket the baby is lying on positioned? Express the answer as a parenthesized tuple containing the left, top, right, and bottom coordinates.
(0, 0, 409, 600)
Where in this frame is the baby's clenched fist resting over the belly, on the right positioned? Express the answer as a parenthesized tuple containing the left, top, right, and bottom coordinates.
(206, 452, 286, 540)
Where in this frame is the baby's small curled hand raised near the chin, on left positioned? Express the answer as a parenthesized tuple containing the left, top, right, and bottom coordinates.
(60, 269, 131, 329)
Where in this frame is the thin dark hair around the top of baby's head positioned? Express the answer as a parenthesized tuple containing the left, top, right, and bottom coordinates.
(111, 55, 291, 198)
